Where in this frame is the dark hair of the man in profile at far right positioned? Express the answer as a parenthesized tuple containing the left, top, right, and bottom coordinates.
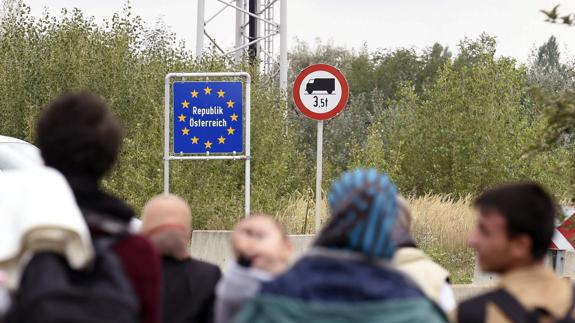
(474, 183, 555, 260)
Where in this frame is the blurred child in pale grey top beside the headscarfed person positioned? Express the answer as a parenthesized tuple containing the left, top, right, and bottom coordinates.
(216, 215, 293, 323)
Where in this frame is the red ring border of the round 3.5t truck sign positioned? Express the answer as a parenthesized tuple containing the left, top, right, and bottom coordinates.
(293, 64, 349, 121)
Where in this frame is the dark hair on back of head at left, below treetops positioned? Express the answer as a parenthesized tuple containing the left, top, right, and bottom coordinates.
(37, 92, 122, 180)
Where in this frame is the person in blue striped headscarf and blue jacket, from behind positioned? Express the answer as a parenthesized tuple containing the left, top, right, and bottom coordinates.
(234, 169, 445, 323)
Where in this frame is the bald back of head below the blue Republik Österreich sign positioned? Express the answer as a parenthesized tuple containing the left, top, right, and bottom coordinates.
(140, 195, 192, 260)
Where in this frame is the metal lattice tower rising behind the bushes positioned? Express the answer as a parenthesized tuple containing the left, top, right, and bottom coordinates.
(196, 0, 287, 91)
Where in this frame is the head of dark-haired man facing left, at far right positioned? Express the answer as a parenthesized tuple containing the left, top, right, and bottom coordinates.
(469, 183, 555, 273)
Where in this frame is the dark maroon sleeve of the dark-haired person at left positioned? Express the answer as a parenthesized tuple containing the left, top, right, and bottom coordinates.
(114, 235, 162, 323)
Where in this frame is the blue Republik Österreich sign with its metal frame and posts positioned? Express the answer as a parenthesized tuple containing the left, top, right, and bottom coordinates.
(164, 72, 251, 217)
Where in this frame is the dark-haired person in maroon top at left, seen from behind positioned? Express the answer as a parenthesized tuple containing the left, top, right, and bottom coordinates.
(37, 92, 161, 323)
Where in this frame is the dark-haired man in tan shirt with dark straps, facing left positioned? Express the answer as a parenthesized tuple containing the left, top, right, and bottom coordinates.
(453, 183, 575, 322)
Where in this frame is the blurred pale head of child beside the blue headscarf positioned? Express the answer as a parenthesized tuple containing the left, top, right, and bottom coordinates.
(231, 214, 293, 273)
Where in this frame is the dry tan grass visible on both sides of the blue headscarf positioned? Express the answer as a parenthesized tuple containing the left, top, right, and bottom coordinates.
(276, 192, 475, 283)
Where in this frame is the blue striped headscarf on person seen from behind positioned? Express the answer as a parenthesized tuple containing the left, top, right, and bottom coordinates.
(315, 169, 398, 259)
